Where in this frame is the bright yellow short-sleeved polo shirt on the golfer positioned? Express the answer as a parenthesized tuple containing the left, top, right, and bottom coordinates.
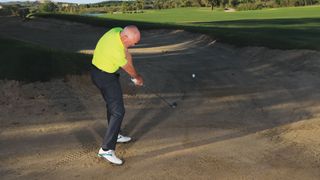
(92, 27, 127, 73)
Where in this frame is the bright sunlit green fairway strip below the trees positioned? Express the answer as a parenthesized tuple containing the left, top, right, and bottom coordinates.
(102, 6, 320, 22)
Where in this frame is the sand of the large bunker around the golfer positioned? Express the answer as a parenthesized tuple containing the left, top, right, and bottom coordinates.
(0, 17, 320, 180)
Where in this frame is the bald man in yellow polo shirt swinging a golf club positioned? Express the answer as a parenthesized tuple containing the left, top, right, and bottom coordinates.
(91, 25, 143, 165)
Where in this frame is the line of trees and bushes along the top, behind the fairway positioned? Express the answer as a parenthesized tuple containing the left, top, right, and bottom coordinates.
(0, 0, 320, 15)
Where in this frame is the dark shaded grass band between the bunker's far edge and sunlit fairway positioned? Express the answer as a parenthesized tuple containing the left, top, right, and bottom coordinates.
(35, 14, 320, 50)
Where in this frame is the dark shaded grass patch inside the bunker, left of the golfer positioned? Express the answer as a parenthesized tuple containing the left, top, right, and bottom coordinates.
(0, 38, 91, 82)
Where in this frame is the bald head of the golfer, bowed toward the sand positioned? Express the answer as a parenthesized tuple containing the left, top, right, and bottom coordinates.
(120, 25, 140, 47)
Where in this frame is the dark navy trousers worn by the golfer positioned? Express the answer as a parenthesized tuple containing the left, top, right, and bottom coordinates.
(90, 65, 125, 150)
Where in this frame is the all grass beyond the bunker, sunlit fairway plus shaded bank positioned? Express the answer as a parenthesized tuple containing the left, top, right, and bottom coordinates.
(37, 6, 320, 50)
